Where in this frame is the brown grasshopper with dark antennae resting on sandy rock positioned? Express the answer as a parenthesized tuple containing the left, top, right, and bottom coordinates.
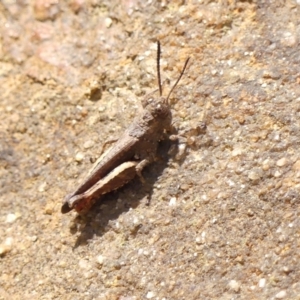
(61, 41, 189, 214)
